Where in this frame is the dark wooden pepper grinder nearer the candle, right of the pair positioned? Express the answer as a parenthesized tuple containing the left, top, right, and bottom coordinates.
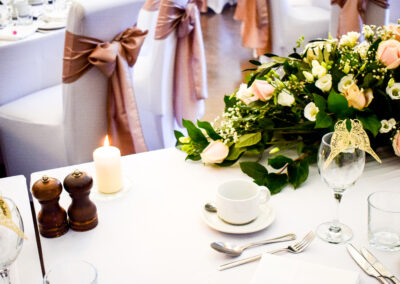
(64, 170, 98, 232)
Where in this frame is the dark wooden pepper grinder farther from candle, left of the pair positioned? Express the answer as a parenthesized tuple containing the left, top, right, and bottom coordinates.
(32, 176, 68, 238)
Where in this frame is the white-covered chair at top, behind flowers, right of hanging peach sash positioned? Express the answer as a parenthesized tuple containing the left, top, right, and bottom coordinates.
(269, 0, 330, 56)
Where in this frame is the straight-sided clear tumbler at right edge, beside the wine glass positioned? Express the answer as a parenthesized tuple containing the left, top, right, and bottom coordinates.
(368, 191, 400, 251)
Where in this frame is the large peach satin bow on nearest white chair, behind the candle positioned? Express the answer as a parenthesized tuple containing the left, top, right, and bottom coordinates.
(63, 27, 147, 155)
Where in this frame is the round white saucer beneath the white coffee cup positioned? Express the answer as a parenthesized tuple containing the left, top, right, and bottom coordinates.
(203, 203, 275, 234)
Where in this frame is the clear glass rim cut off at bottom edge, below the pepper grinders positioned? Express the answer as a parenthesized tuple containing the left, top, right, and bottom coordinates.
(43, 260, 97, 284)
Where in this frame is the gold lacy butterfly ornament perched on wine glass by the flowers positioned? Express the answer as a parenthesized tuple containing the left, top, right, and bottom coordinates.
(324, 119, 382, 169)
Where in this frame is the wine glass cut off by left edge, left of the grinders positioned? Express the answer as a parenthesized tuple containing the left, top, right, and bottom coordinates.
(0, 197, 24, 284)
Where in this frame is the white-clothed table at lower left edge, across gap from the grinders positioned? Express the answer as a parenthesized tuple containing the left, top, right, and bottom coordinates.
(0, 176, 42, 284)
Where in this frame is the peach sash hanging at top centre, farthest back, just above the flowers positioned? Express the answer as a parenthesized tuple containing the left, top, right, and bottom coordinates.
(234, 0, 271, 55)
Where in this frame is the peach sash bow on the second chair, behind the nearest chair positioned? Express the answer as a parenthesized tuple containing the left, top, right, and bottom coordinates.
(155, 0, 208, 126)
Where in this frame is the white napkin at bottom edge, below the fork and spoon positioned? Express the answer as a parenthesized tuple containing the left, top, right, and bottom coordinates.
(251, 253, 359, 284)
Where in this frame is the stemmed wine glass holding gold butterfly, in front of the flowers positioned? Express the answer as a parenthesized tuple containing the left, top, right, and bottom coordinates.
(317, 132, 365, 244)
